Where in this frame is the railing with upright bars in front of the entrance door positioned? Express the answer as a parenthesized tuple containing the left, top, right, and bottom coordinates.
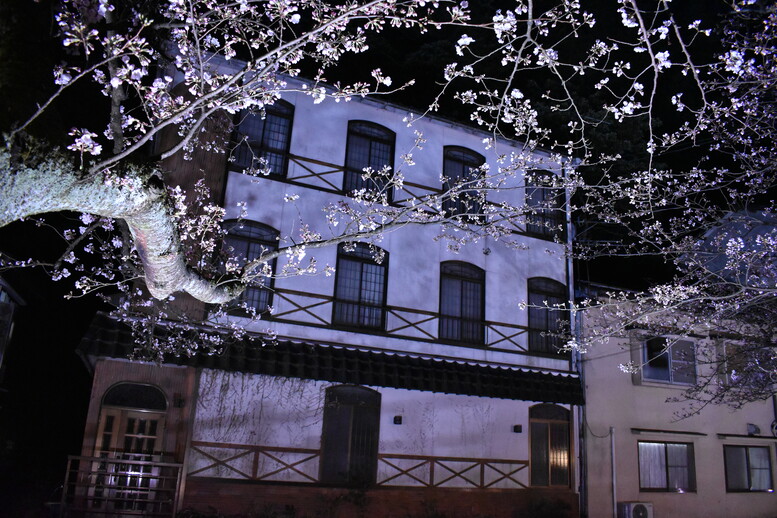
(62, 453, 182, 518)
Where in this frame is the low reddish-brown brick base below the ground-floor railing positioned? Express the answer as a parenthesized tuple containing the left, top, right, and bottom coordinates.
(181, 477, 579, 518)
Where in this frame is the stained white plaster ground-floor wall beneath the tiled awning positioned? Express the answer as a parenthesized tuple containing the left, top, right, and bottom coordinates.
(188, 369, 568, 488)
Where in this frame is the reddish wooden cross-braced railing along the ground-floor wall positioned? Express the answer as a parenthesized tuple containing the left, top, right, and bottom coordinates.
(187, 441, 529, 489)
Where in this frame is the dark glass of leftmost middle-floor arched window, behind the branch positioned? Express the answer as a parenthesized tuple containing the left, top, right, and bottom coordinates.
(224, 221, 279, 313)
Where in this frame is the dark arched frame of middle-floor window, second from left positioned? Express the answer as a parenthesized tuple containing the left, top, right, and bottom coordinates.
(331, 243, 389, 331)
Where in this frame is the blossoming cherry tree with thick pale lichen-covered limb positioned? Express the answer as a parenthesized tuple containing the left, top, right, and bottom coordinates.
(0, 0, 777, 402)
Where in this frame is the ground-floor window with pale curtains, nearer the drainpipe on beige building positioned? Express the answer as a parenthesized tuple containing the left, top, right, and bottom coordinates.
(639, 441, 696, 493)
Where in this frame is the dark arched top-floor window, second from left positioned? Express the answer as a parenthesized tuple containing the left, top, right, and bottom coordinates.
(343, 121, 395, 201)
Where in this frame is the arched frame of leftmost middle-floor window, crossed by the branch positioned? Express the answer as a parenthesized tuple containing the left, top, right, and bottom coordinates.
(223, 219, 280, 316)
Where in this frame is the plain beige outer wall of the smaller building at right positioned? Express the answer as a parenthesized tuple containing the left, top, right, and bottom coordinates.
(583, 312, 777, 518)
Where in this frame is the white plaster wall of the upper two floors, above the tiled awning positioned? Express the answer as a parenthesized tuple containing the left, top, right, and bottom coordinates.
(218, 82, 569, 370)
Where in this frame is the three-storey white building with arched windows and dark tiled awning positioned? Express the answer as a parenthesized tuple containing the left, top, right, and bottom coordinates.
(64, 78, 583, 518)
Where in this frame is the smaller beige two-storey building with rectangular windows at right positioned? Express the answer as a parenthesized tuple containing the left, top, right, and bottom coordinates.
(582, 300, 777, 518)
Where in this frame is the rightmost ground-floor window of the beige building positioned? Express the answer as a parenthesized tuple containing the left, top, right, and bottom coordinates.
(723, 446, 774, 492)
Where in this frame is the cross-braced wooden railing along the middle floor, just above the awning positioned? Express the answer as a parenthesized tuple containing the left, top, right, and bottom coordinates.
(270, 288, 528, 352)
